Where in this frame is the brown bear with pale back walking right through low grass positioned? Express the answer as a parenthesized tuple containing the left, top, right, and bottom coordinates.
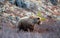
(18, 17, 40, 32)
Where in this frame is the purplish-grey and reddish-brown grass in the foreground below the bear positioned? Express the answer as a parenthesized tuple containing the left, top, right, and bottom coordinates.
(0, 20, 60, 38)
